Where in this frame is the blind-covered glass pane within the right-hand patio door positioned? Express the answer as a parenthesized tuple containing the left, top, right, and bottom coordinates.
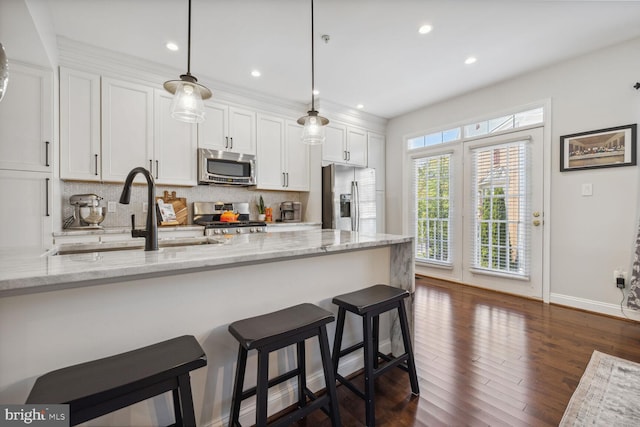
(470, 141, 530, 276)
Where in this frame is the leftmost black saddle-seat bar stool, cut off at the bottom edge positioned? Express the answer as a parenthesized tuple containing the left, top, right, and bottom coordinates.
(27, 335, 207, 426)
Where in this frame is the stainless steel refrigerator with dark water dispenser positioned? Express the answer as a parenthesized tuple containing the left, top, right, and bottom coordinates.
(322, 164, 376, 233)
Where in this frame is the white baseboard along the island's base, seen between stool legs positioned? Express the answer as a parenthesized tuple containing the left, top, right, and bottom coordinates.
(206, 339, 391, 427)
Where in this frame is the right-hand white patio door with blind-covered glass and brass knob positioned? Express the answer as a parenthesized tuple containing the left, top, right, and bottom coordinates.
(459, 128, 544, 299)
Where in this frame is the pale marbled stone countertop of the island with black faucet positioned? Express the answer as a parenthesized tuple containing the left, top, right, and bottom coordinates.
(0, 230, 412, 297)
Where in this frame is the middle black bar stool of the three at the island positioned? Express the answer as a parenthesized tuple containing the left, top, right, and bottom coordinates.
(229, 304, 341, 427)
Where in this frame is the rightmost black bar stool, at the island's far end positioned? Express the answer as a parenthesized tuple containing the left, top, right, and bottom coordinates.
(333, 285, 420, 427)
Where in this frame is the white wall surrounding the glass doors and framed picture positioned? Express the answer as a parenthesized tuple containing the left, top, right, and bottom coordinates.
(387, 39, 640, 319)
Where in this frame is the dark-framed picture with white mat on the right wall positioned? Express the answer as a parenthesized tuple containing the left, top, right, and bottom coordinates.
(560, 124, 638, 172)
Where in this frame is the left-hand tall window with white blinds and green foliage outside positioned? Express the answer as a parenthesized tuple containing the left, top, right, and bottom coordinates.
(413, 154, 452, 263)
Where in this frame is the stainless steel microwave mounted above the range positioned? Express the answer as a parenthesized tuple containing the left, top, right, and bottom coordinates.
(198, 148, 256, 186)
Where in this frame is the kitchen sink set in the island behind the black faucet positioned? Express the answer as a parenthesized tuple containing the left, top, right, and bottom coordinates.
(53, 236, 224, 255)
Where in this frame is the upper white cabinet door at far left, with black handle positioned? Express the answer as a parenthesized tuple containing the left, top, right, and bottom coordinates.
(0, 62, 54, 172)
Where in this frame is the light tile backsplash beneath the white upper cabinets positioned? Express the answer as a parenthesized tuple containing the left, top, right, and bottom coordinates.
(61, 181, 308, 227)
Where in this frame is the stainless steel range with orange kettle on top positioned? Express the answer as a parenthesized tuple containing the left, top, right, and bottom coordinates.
(193, 202, 267, 236)
